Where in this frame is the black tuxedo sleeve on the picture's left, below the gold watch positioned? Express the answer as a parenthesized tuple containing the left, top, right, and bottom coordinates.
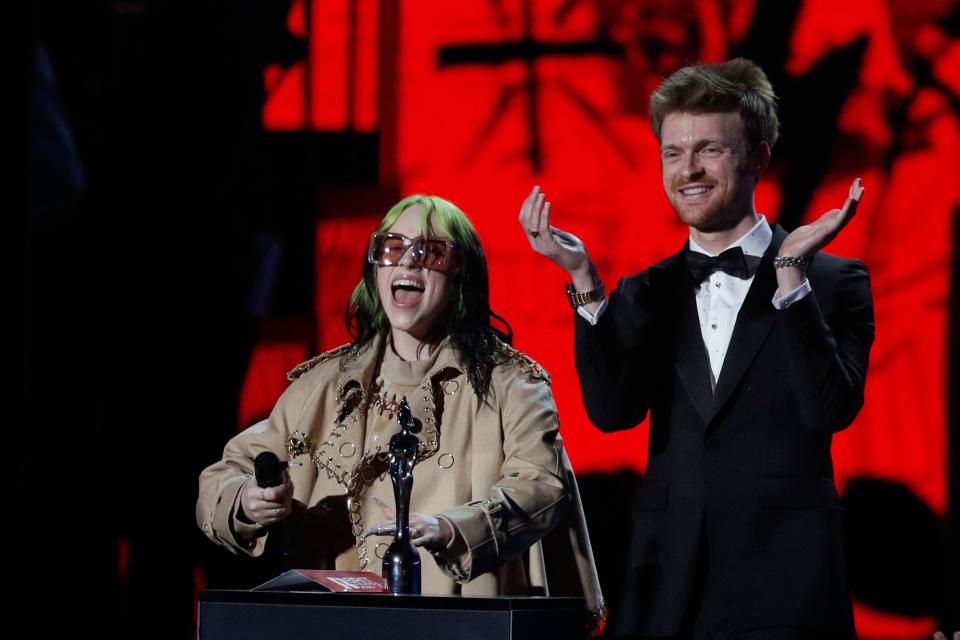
(574, 271, 655, 431)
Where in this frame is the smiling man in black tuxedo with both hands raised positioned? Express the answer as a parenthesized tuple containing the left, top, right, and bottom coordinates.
(520, 59, 873, 640)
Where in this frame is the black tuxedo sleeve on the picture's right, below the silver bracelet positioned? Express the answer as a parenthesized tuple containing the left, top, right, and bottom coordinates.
(778, 256, 874, 431)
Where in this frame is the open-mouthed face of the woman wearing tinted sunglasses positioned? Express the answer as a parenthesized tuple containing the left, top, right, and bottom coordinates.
(376, 205, 452, 341)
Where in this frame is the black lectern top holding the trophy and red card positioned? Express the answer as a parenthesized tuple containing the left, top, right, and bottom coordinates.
(200, 590, 587, 640)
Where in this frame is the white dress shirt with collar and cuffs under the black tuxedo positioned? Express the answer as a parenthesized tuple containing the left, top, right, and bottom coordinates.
(577, 214, 811, 387)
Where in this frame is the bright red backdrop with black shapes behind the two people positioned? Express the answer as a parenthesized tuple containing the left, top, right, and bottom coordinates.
(232, 0, 960, 638)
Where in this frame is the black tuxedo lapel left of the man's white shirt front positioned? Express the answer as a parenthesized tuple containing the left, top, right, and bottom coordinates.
(650, 249, 713, 424)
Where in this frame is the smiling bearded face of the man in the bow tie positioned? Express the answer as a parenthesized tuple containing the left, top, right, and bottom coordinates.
(660, 111, 766, 233)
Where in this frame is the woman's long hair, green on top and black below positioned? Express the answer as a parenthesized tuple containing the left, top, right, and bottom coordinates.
(346, 194, 511, 398)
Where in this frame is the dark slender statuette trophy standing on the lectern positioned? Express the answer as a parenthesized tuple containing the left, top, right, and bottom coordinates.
(383, 399, 421, 594)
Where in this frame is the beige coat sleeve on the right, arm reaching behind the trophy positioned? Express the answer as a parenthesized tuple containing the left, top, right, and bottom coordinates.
(434, 365, 570, 582)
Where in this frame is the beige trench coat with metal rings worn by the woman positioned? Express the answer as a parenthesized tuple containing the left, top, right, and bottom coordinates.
(196, 340, 603, 628)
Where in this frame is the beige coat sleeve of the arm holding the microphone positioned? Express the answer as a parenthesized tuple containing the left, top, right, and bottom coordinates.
(196, 368, 324, 556)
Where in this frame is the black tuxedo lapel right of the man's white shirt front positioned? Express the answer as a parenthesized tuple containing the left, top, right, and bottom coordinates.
(708, 226, 786, 421)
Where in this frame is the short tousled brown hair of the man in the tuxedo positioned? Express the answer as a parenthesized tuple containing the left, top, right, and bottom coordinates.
(650, 58, 780, 149)
